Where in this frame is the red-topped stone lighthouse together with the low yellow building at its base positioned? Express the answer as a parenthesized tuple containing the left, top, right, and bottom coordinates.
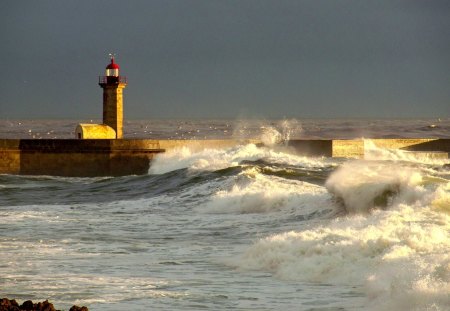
(75, 55, 127, 139)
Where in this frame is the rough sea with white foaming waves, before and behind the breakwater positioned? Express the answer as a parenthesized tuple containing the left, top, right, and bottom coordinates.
(0, 118, 450, 311)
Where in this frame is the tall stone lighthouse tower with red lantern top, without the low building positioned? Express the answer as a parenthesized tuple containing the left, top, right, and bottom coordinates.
(98, 56, 127, 139)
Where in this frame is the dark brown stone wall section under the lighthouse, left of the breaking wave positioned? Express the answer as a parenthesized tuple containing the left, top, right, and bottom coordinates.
(0, 139, 163, 177)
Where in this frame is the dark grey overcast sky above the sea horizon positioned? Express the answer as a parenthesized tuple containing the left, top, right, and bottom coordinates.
(0, 0, 450, 120)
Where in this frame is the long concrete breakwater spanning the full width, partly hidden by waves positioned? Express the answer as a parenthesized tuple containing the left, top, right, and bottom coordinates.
(0, 138, 450, 177)
